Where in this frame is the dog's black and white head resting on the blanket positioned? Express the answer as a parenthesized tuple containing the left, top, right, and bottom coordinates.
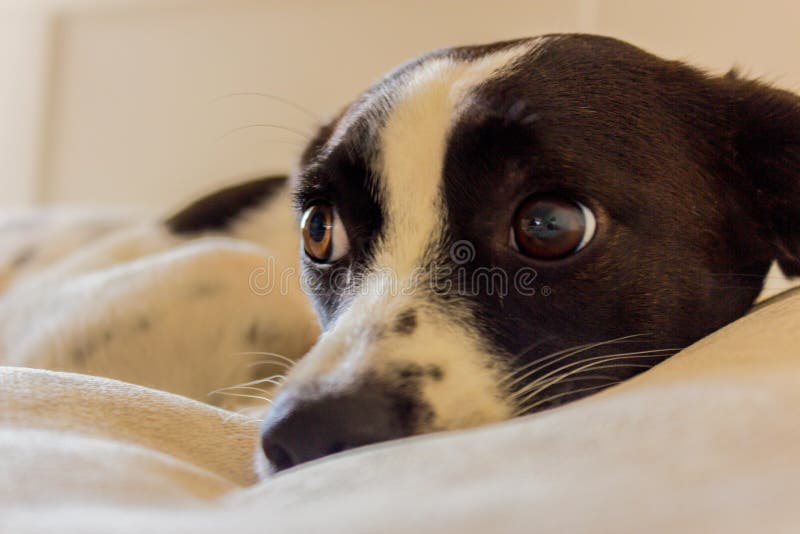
(263, 36, 800, 469)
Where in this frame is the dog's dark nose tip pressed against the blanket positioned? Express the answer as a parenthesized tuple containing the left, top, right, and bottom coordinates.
(261, 390, 408, 471)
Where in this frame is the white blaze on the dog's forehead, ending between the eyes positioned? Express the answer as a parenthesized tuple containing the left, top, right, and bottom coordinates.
(376, 42, 534, 279)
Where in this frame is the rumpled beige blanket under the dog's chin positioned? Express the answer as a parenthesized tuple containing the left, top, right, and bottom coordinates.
(0, 294, 800, 534)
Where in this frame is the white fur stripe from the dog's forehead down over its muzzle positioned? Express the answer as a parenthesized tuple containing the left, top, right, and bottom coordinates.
(290, 42, 538, 430)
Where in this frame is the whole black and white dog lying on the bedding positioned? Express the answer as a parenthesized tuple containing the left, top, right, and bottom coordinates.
(0, 34, 800, 474)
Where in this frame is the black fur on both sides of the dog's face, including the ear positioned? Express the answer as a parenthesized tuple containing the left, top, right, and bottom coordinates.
(266, 35, 800, 468)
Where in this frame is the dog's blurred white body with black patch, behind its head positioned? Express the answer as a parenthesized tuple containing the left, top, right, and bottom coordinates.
(0, 180, 318, 414)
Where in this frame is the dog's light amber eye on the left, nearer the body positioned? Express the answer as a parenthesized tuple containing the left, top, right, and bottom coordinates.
(300, 204, 348, 263)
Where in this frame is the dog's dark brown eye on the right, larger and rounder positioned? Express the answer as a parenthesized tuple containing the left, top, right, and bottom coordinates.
(510, 199, 597, 260)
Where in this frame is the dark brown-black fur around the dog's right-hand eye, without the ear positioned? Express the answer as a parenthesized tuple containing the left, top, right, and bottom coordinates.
(444, 36, 780, 376)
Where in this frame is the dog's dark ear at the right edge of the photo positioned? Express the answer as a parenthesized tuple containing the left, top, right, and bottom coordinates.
(725, 73, 800, 276)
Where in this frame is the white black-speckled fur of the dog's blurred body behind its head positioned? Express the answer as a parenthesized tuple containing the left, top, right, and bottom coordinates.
(0, 193, 317, 407)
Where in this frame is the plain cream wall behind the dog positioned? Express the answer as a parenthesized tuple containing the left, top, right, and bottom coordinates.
(0, 0, 800, 212)
